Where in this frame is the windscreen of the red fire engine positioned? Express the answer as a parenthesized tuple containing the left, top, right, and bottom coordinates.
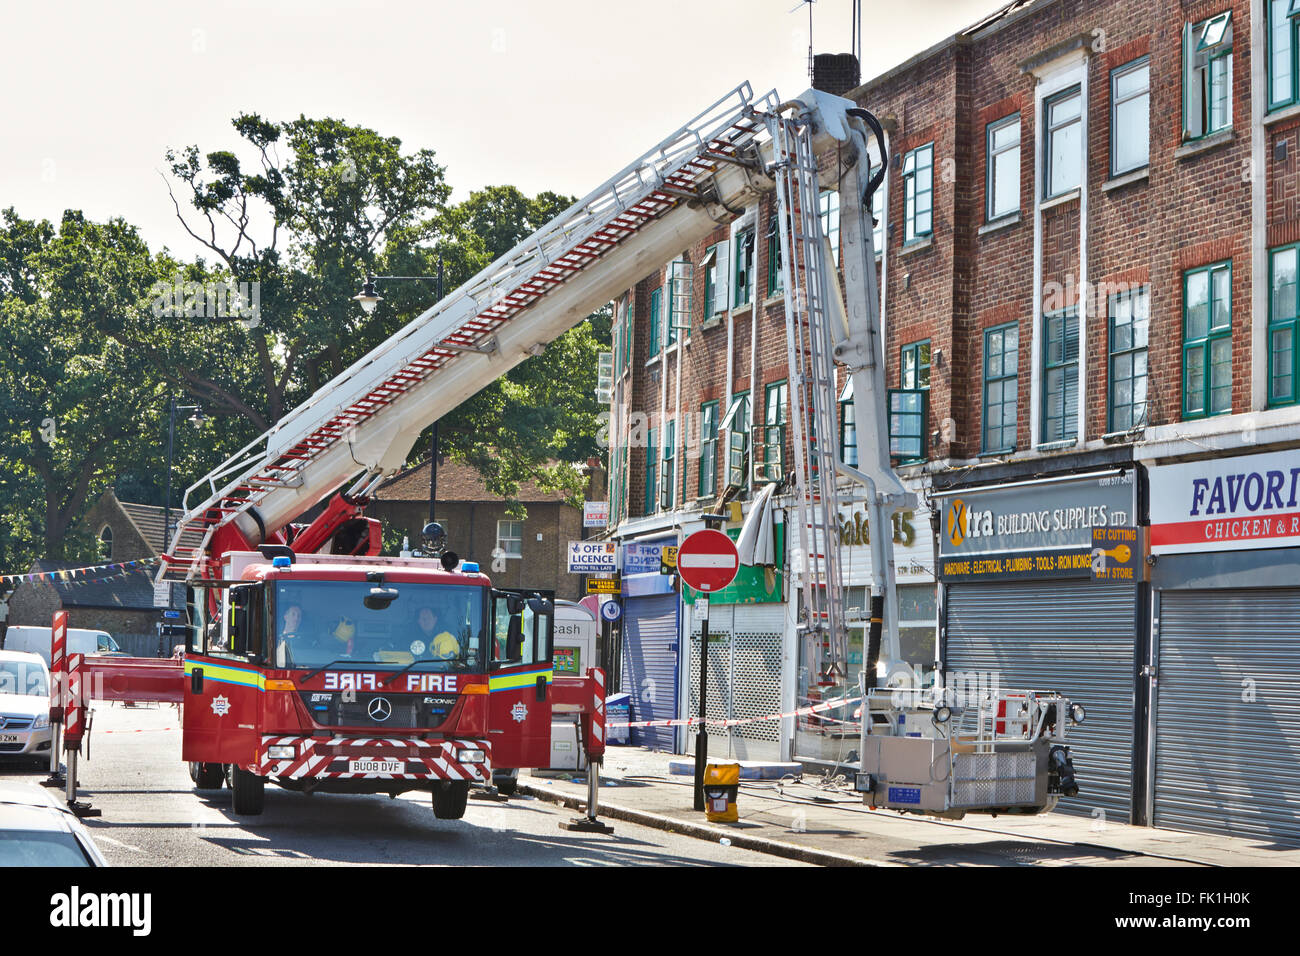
(272, 580, 486, 672)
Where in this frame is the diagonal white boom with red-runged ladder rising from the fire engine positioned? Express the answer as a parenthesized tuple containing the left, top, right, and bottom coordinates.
(159, 83, 777, 580)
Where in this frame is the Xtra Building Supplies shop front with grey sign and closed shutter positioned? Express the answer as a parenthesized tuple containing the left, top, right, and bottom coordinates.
(935, 468, 1143, 822)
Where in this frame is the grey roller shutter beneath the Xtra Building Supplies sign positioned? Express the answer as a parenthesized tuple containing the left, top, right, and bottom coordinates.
(945, 581, 1136, 822)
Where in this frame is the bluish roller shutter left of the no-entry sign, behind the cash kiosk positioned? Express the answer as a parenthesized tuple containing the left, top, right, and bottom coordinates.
(623, 594, 677, 753)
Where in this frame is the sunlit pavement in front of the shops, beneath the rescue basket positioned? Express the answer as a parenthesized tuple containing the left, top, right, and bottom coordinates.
(519, 747, 1300, 866)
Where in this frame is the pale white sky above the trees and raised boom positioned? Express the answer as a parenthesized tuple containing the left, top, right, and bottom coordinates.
(0, 0, 1001, 259)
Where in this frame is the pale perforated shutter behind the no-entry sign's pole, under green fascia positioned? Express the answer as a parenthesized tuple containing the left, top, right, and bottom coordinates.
(686, 605, 785, 760)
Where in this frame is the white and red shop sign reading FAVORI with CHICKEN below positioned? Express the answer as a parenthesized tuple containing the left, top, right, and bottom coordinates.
(1149, 451, 1300, 554)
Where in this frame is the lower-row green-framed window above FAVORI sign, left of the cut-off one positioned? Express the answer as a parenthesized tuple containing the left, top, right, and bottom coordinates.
(1183, 260, 1232, 419)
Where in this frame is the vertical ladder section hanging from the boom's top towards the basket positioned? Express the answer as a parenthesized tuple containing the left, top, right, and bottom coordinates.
(768, 116, 848, 685)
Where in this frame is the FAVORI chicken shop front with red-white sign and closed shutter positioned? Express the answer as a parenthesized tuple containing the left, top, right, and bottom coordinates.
(1144, 450, 1300, 845)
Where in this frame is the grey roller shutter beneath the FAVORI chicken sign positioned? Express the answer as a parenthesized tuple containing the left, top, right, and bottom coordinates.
(1152, 589, 1300, 844)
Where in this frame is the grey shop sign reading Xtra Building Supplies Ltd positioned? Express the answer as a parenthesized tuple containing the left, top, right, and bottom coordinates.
(939, 472, 1136, 556)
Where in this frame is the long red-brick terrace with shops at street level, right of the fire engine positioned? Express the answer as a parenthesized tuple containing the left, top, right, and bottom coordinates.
(611, 0, 1300, 842)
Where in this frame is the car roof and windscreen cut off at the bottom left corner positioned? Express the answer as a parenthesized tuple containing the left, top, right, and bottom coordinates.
(0, 786, 108, 866)
